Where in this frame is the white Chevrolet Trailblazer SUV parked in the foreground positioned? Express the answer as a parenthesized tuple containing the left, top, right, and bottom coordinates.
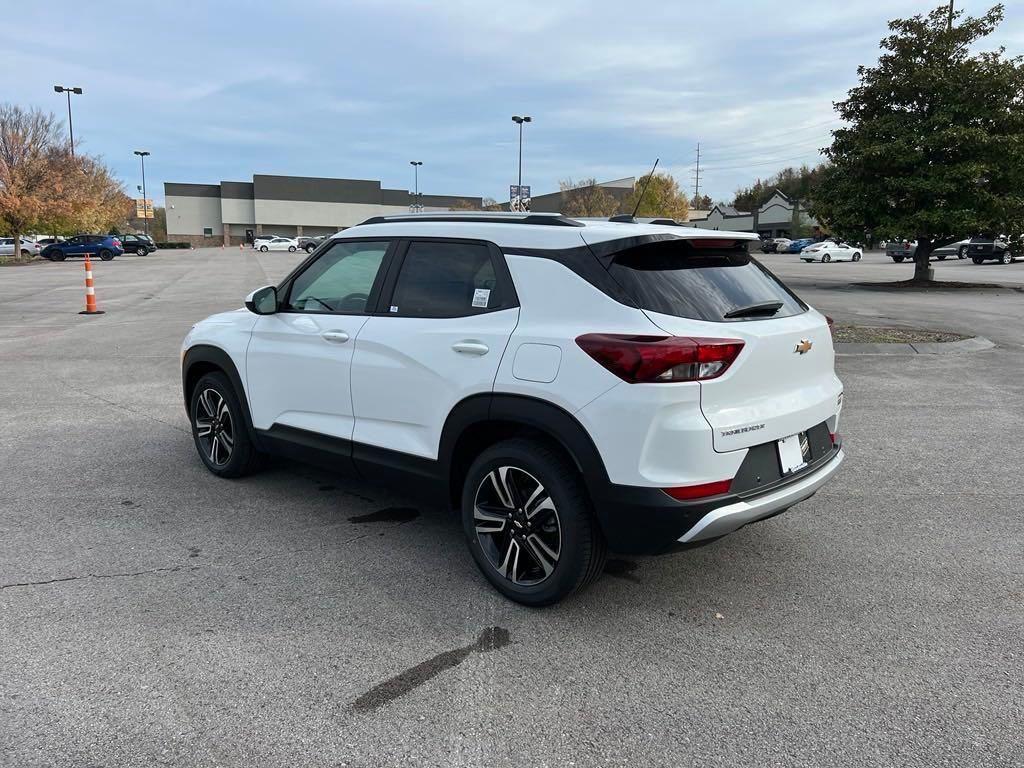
(181, 213, 843, 605)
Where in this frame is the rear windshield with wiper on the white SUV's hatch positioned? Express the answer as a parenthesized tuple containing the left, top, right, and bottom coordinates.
(608, 240, 807, 322)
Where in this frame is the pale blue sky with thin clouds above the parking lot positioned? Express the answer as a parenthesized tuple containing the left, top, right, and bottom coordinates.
(0, 0, 1024, 204)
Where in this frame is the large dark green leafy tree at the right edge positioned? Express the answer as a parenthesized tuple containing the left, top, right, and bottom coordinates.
(812, 5, 1024, 282)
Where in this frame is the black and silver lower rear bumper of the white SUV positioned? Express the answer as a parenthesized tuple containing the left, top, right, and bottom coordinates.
(592, 445, 845, 555)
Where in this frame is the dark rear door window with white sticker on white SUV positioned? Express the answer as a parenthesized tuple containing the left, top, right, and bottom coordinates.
(389, 242, 511, 317)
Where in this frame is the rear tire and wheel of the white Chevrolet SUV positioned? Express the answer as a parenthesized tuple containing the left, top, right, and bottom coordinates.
(462, 438, 607, 606)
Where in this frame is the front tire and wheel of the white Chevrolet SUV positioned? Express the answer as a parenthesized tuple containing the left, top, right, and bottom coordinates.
(188, 371, 259, 477)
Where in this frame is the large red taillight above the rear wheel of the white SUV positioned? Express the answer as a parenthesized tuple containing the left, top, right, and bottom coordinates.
(577, 334, 743, 384)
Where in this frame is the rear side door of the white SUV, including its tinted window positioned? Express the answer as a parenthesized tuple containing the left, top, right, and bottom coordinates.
(352, 239, 519, 461)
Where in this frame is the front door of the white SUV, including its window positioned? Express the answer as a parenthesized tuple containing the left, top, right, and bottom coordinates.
(246, 239, 391, 441)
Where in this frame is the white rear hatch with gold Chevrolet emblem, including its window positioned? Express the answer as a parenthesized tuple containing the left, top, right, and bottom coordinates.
(608, 233, 842, 452)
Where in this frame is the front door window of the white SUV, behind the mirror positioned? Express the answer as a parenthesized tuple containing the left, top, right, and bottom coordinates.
(285, 241, 390, 314)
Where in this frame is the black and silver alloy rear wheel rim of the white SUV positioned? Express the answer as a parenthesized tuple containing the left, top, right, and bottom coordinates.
(473, 466, 562, 587)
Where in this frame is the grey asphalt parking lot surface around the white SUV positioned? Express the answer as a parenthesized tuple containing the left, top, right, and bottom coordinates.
(0, 249, 1024, 767)
